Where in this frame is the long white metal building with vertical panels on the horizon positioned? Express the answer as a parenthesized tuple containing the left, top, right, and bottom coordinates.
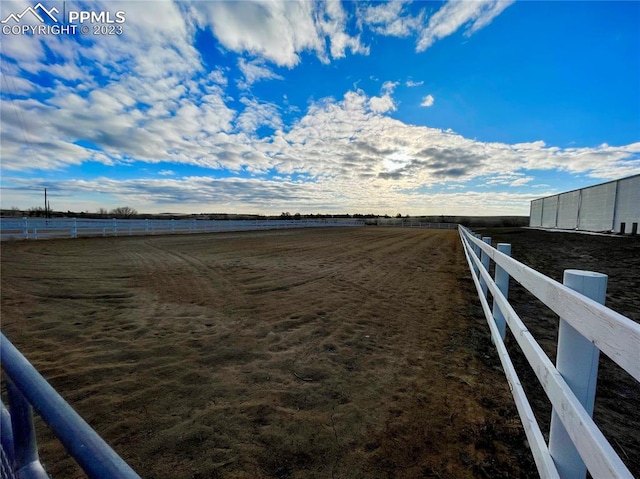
(529, 175, 640, 234)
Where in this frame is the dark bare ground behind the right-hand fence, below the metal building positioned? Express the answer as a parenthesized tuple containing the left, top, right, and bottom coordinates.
(477, 228, 640, 478)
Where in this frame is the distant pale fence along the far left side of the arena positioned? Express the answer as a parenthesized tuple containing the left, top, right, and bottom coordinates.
(0, 218, 364, 240)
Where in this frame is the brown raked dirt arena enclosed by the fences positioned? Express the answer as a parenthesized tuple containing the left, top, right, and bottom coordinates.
(1, 227, 537, 478)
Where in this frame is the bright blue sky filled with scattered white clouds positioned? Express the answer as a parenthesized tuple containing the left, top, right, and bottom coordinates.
(0, 0, 640, 215)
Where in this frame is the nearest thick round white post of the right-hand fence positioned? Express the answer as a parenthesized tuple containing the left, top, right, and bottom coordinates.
(549, 269, 607, 479)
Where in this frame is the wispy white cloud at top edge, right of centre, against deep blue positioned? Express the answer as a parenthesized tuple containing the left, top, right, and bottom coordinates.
(416, 0, 514, 52)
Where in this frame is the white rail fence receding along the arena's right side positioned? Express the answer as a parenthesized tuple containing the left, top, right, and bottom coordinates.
(459, 226, 640, 479)
